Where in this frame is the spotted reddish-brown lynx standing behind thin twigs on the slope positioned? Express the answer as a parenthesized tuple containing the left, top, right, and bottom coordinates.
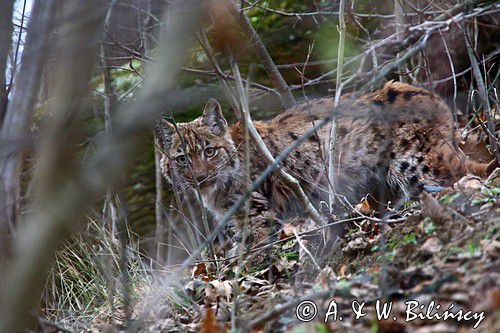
(157, 81, 487, 253)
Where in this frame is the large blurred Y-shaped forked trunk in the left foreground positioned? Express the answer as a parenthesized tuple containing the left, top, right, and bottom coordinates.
(0, 1, 201, 332)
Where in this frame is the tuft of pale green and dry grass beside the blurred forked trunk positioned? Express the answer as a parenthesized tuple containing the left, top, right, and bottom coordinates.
(42, 220, 152, 331)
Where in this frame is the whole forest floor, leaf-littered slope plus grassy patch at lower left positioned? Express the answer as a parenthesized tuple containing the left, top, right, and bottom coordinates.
(41, 168, 500, 333)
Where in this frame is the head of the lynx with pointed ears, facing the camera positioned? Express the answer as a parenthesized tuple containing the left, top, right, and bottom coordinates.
(155, 98, 239, 191)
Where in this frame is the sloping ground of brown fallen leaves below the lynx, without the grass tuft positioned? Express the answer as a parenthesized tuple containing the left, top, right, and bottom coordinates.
(141, 169, 500, 333)
